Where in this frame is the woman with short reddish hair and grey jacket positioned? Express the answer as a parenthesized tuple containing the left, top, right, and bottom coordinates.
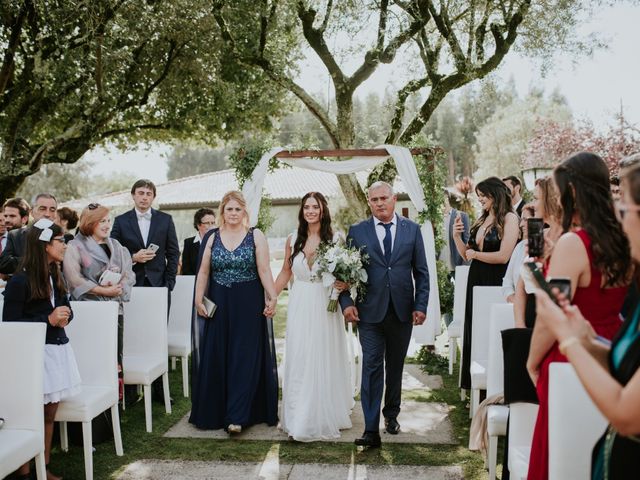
(63, 203, 136, 380)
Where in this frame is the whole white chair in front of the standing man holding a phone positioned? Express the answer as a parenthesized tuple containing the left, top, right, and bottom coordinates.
(122, 287, 171, 432)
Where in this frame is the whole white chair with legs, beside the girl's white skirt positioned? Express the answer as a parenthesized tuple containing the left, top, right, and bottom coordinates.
(56, 302, 124, 480)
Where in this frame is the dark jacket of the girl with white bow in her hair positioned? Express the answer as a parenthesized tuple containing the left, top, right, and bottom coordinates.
(2, 272, 73, 345)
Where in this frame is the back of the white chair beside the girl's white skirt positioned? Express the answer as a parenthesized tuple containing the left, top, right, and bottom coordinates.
(65, 301, 118, 395)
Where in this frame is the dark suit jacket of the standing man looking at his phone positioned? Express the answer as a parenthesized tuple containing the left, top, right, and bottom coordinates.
(111, 209, 180, 290)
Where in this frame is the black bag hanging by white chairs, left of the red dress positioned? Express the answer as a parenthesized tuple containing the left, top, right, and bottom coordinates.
(502, 328, 538, 404)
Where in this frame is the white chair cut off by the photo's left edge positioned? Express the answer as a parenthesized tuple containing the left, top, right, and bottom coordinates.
(0, 322, 47, 480)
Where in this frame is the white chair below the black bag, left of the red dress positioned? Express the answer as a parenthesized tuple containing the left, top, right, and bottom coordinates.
(507, 403, 538, 480)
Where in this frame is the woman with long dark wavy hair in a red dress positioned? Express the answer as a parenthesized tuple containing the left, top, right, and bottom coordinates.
(527, 152, 631, 480)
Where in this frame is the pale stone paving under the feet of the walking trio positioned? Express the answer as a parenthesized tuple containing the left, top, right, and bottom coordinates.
(164, 365, 455, 444)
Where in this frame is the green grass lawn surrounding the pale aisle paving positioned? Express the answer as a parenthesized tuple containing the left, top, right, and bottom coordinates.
(51, 306, 490, 480)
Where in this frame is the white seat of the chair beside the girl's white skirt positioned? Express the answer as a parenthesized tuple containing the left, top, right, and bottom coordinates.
(56, 385, 118, 422)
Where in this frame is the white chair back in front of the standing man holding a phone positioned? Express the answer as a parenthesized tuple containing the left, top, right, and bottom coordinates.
(123, 287, 168, 365)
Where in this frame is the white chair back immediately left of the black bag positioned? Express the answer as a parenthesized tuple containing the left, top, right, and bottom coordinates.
(487, 303, 515, 397)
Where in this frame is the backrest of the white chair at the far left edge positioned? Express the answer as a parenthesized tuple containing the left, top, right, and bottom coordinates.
(0, 322, 47, 435)
